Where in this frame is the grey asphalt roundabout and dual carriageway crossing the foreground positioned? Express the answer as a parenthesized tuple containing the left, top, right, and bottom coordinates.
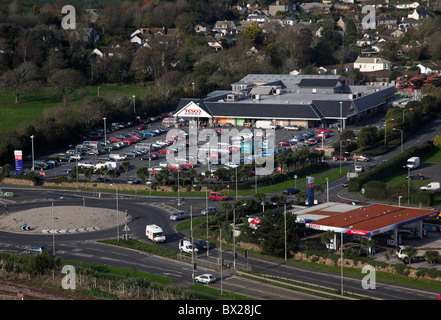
(0, 189, 436, 300)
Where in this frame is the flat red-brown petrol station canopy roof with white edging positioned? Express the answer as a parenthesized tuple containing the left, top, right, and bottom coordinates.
(300, 203, 439, 236)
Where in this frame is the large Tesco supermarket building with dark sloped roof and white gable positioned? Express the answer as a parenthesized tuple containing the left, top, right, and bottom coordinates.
(173, 74, 396, 129)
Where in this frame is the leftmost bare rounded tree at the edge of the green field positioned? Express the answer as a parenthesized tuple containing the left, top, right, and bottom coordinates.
(1, 62, 37, 104)
